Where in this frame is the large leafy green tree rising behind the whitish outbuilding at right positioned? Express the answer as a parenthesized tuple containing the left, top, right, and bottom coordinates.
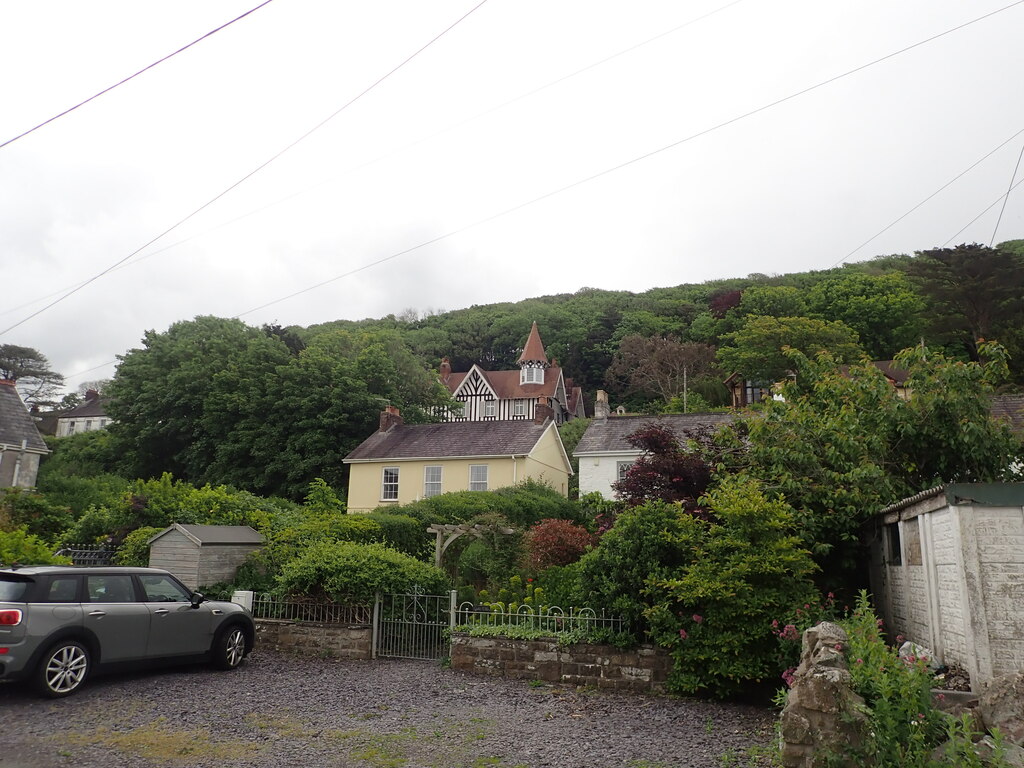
(730, 345, 1021, 590)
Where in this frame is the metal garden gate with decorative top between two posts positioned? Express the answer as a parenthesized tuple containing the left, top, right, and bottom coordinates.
(373, 588, 456, 659)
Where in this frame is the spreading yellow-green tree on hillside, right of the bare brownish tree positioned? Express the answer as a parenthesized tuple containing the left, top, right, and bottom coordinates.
(718, 316, 863, 382)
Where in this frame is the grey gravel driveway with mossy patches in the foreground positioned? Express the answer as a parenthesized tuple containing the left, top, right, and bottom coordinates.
(0, 650, 773, 768)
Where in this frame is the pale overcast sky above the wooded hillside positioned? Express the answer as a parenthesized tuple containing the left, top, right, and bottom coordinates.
(0, 0, 1024, 389)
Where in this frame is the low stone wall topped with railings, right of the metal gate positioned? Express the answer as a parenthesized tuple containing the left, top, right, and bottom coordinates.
(452, 635, 672, 693)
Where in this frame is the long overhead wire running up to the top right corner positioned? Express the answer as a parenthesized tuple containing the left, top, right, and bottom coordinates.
(233, 0, 1024, 317)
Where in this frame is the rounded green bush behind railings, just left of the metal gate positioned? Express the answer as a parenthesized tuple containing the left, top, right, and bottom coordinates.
(276, 542, 449, 601)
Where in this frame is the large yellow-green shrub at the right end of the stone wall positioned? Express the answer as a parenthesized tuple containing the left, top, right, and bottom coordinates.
(643, 476, 816, 695)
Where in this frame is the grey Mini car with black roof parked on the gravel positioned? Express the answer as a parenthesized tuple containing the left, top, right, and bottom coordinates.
(0, 566, 256, 697)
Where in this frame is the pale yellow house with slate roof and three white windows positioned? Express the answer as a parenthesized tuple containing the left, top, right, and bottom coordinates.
(344, 407, 572, 512)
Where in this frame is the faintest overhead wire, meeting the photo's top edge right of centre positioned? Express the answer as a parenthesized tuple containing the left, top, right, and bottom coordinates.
(0, 0, 743, 316)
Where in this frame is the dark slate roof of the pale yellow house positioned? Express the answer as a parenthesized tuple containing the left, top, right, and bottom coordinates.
(344, 421, 551, 462)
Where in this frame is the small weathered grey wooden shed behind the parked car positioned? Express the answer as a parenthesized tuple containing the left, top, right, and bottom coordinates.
(150, 523, 264, 590)
